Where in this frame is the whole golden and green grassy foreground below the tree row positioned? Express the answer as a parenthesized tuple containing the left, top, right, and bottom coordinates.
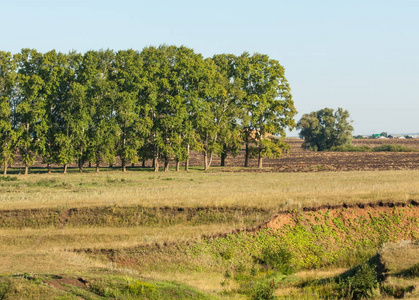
(0, 168, 419, 299)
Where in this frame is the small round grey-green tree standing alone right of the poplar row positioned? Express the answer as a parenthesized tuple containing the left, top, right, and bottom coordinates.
(297, 108, 353, 151)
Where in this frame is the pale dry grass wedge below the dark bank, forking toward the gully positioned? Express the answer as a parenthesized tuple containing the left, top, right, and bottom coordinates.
(0, 224, 243, 273)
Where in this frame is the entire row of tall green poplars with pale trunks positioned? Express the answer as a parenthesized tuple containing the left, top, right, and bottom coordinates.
(0, 45, 296, 174)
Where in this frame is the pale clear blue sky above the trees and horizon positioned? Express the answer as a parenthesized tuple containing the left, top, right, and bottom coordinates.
(0, 0, 419, 136)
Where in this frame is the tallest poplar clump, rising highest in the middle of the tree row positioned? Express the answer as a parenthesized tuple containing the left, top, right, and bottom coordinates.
(141, 45, 203, 172)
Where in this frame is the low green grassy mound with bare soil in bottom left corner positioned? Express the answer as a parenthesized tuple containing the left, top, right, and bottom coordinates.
(0, 273, 214, 300)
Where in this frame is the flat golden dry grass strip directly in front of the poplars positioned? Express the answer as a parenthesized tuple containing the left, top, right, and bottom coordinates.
(0, 170, 419, 210)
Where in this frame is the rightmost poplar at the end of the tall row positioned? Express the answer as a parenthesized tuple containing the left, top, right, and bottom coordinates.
(238, 53, 297, 168)
